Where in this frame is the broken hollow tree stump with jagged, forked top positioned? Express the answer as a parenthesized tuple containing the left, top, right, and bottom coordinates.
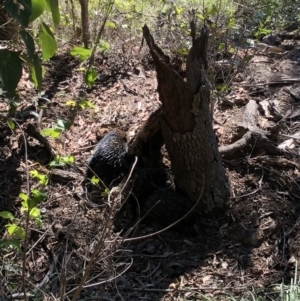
(133, 22, 229, 216)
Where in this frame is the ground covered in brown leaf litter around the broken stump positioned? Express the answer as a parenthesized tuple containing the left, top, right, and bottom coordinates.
(0, 31, 300, 301)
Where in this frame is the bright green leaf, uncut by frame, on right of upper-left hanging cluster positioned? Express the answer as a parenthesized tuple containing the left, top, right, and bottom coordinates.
(39, 22, 57, 61)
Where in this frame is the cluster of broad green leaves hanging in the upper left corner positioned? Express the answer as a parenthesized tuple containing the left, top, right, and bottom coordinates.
(0, 0, 60, 113)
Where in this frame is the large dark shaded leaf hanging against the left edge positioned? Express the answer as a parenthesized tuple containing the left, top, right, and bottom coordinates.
(0, 49, 22, 97)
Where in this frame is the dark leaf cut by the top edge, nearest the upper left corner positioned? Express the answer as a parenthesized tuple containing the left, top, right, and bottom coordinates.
(2, 0, 31, 27)
